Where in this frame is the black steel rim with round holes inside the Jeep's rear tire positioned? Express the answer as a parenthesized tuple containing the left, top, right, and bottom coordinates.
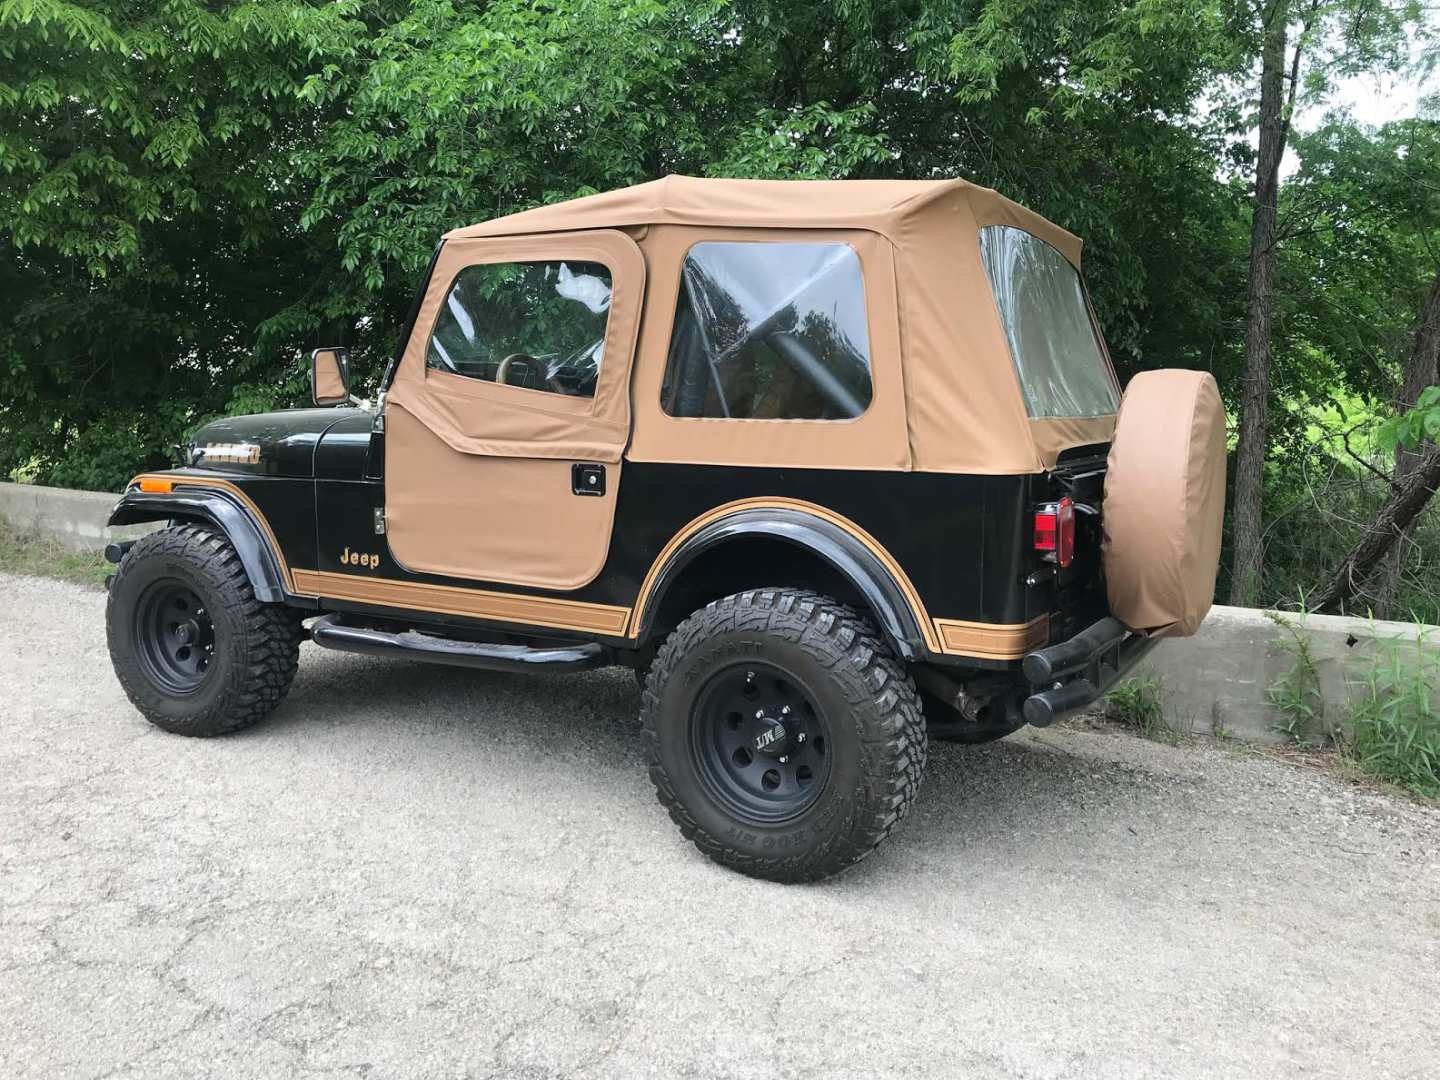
(690, 661, 831, 824)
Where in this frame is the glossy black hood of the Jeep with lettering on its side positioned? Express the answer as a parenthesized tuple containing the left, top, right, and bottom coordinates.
(184, 409, 366, 477)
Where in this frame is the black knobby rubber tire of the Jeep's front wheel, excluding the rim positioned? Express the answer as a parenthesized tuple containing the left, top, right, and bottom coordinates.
(105, 524, 301, 737)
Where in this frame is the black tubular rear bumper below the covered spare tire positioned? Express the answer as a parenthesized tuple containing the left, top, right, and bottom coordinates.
(1021, 616, 1158, 727)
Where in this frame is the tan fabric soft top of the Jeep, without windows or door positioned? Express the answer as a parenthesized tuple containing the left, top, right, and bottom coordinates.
(423, 176, 1115, 474)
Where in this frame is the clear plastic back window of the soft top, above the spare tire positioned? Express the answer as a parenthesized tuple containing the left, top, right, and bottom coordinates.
(981, 225, 1120, 416)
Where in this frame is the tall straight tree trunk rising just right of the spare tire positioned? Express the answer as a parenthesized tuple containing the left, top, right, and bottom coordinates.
(1230, 0, 1300, 605)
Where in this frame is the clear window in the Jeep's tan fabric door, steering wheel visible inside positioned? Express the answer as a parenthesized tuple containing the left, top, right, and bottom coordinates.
(425, 261, 612, 397)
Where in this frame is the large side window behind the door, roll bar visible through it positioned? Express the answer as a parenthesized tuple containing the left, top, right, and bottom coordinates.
(660, 242, 871, 420)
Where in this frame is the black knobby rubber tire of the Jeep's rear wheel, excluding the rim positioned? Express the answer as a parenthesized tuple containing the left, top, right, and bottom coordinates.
(641, 588, 927, 881)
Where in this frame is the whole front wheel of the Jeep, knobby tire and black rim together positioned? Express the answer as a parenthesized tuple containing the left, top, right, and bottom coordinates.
(105, 524, 300, 736)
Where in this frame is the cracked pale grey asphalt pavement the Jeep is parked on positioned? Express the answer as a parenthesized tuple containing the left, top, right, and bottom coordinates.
(0, 576, 1440, 1080)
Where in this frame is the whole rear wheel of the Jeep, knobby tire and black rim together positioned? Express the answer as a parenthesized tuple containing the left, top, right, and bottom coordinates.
(641, 588, 926, 881)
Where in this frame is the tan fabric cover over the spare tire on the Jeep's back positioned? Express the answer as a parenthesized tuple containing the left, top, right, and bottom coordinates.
(1103, 370, 1225, 638)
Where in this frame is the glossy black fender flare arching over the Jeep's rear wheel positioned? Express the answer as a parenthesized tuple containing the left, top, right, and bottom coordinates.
(635, 507, 927, 661)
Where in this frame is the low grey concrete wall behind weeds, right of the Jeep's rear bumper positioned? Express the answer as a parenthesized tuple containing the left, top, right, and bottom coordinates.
(1132, 606, 1440, 742)
